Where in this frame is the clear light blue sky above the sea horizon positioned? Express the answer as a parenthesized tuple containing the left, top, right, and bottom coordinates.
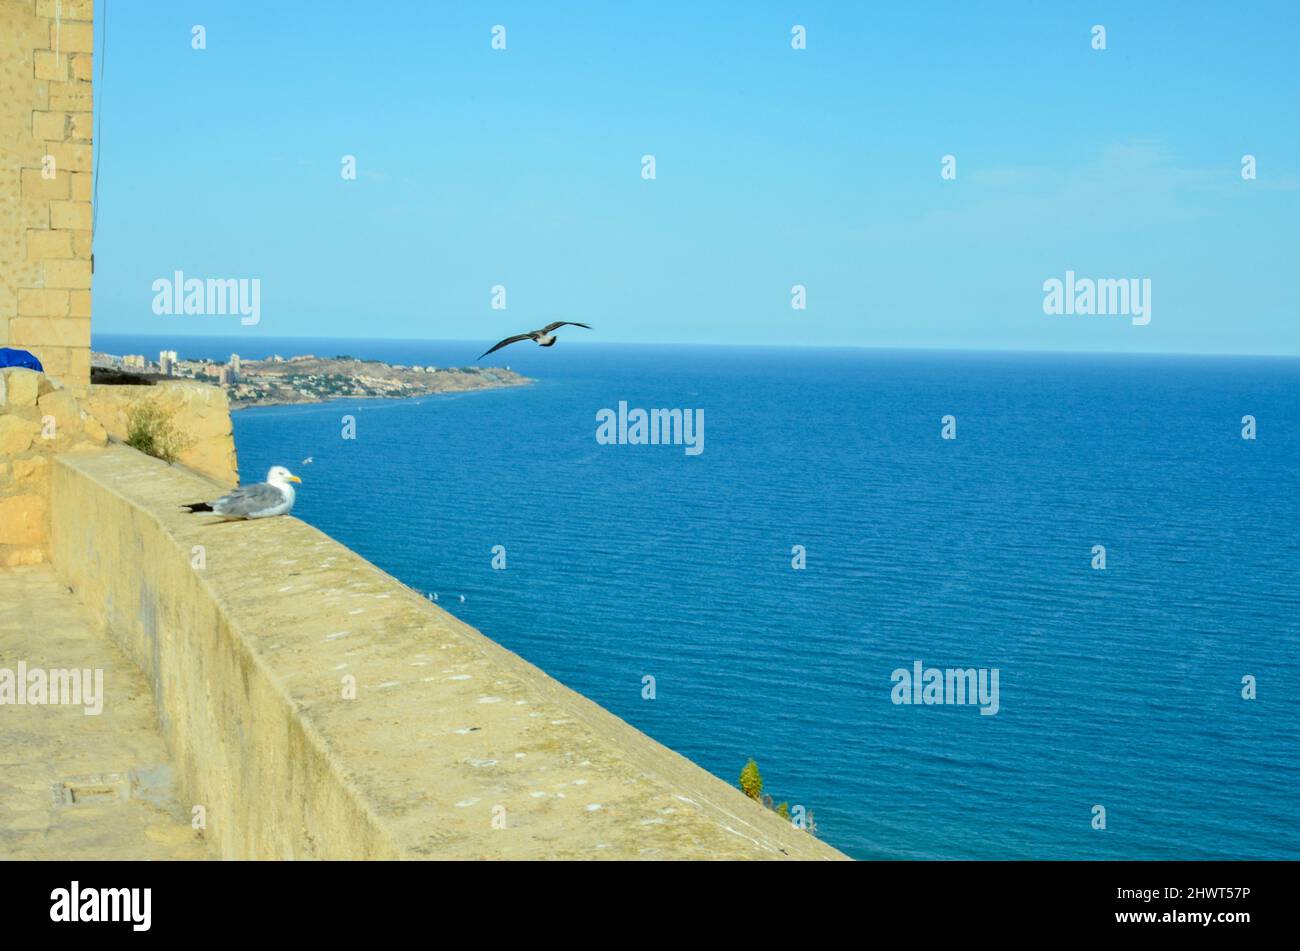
(94, 0, 1300, 355)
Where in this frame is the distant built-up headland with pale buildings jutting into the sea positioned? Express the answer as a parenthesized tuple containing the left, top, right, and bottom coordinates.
(91, 351, 534, 411)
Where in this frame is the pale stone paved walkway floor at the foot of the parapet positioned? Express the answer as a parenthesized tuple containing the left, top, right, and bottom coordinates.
(0, 563, 212, 861)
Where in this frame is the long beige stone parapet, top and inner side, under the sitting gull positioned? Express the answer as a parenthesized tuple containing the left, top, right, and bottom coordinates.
(52, 447, 844, 859)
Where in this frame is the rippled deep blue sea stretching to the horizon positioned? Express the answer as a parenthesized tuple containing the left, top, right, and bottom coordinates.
(95, 331, 1300, 859)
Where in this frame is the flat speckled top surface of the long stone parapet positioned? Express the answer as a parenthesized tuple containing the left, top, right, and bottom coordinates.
(57, 447, 846, 859)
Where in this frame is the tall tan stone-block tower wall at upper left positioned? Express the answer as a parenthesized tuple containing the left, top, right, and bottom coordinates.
(0, 0, 95, 392)
